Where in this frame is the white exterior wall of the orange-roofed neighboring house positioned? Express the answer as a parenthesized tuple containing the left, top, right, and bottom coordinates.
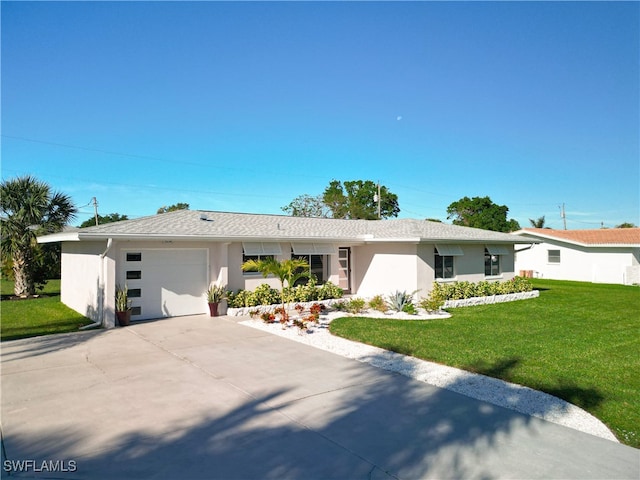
(515, 240, 640, 284)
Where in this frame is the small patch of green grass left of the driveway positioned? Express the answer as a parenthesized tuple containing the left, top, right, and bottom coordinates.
(0, 279, 91, 341)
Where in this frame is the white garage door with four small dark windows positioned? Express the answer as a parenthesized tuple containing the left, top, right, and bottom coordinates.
(118, 248, 209, 320)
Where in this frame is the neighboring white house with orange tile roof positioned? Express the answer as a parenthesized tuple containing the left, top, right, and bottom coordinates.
(514, 228, 640, 285)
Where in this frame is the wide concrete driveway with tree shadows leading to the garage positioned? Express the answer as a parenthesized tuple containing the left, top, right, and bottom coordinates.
(2, 316, 640, 479)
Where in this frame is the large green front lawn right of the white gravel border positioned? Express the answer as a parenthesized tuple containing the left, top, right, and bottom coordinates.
(331, 279, 640, 448)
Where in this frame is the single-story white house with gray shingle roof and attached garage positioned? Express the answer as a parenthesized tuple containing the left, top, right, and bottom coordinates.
(38, 210, 531, 327)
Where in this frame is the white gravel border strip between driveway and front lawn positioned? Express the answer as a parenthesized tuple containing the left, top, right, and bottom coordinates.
(239, 312, 618, 442)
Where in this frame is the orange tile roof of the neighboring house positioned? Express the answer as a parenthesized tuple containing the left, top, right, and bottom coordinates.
(516, 228, 640, 246)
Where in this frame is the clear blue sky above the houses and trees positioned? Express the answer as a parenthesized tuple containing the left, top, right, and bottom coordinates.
(1, 2, 640, 229)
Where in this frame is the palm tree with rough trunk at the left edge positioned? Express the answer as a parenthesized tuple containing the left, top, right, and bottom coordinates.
(0, 175, 77, 296)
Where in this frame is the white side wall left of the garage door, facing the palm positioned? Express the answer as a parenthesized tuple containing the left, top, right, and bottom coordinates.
(60, 241, 107, 322)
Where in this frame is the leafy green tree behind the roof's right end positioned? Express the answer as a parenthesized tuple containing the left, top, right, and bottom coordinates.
(447, 197, 520, 232)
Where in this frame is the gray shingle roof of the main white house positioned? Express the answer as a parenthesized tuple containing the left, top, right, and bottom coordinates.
(40, 210, 530, 244)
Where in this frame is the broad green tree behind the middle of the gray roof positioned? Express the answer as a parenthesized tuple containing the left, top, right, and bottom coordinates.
(322, 180, 400, 220)
